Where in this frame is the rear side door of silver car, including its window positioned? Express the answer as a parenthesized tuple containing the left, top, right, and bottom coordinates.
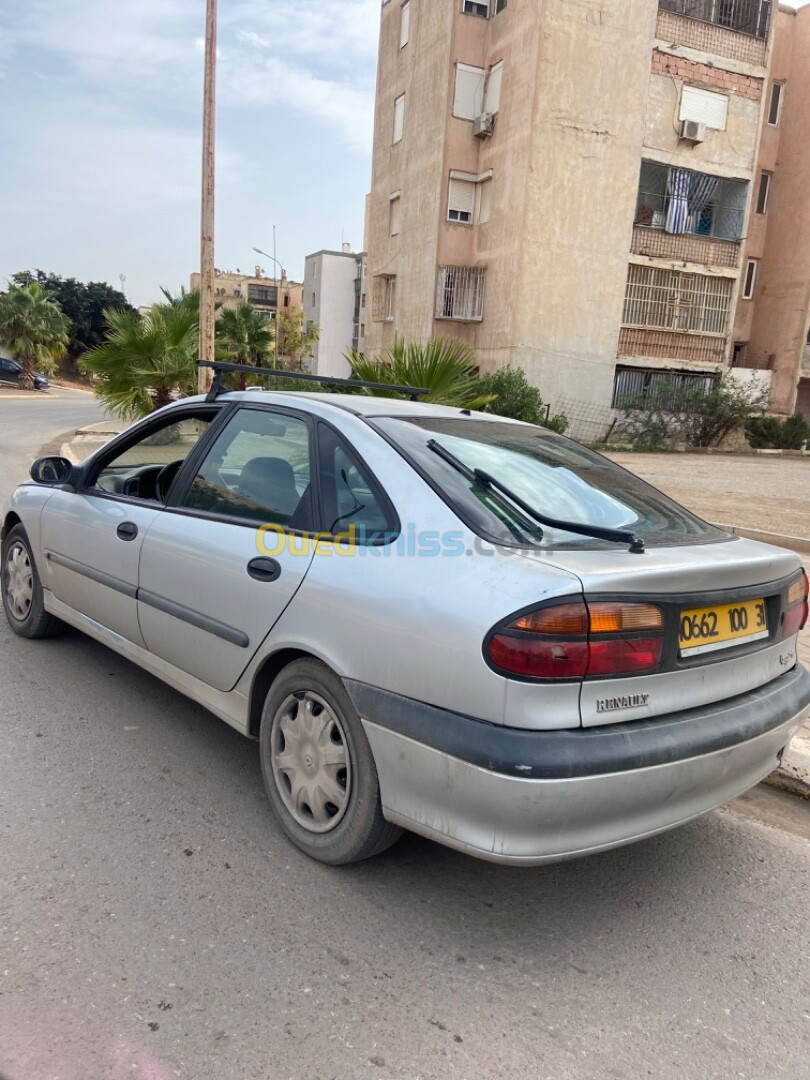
(138, 404, 314, 690)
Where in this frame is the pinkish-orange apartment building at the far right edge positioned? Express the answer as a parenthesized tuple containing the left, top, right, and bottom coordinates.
(733, 4, 810, 419)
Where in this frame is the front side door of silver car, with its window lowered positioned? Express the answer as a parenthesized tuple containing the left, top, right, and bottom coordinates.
(41, 406, 217, 646)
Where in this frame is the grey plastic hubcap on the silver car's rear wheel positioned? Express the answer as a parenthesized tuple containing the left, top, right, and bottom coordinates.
(270, 690, 351, 833)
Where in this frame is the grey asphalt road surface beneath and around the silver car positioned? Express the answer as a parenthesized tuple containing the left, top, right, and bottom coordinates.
(0, 397, 810, 1080)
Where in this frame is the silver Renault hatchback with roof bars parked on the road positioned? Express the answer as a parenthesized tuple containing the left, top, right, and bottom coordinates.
(1, 391, 810, 865)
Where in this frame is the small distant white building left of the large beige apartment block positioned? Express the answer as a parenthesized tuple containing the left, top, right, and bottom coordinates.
(303, 244, 366, 378)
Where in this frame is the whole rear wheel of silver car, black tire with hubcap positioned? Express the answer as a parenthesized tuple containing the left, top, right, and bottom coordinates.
(259, 660, 402, 866)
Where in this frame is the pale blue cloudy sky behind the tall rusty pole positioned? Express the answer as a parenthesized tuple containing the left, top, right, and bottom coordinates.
(0, 0, 806, 305)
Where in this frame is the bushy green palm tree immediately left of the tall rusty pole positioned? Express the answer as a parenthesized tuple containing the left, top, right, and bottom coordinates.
(79, 303, 199, 420)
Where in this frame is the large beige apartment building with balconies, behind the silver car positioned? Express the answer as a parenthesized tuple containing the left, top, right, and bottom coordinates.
(366, 0, 810, 429)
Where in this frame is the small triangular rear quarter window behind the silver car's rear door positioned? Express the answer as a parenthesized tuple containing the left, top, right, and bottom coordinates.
(319, 423, 397, 543)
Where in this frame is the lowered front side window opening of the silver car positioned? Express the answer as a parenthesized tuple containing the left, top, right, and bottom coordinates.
(91, 410, 216, 502)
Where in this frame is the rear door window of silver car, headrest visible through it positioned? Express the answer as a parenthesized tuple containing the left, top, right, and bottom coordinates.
(181, 408, 313, 531)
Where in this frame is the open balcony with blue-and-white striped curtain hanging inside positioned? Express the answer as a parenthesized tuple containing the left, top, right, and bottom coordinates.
(633, 161, 748, 268)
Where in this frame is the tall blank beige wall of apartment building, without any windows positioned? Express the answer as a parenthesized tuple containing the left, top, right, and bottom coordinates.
(513, 0, 658, 404)
